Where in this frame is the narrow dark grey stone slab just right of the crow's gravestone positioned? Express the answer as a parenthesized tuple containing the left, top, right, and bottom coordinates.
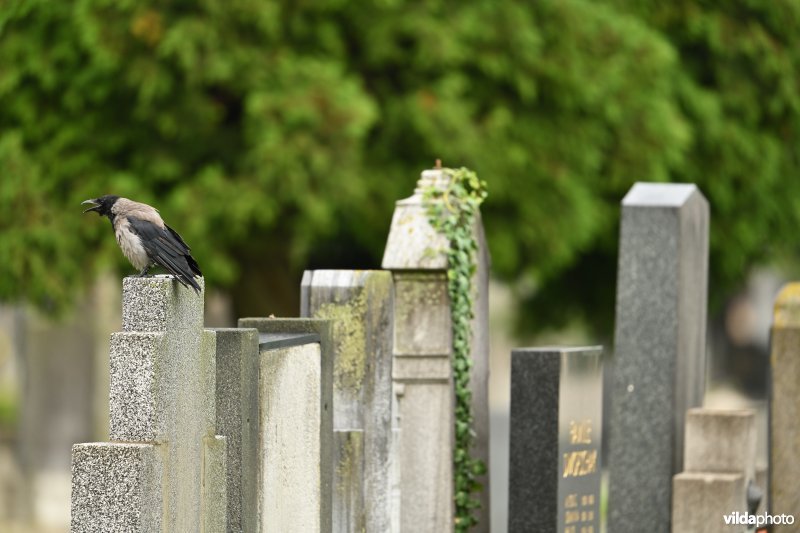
(214, 328, 259, 533)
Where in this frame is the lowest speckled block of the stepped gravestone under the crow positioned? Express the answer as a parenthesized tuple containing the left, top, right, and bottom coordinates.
(70, 443, 164, 533)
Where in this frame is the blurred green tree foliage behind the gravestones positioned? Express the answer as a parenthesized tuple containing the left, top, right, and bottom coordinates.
(0, 0, 800, 334)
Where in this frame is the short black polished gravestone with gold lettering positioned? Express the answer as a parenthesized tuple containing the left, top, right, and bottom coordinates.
(508, 346, 603, 533)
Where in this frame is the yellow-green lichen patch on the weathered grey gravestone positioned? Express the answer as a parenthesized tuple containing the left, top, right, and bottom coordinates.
(314, 291, 366, 391)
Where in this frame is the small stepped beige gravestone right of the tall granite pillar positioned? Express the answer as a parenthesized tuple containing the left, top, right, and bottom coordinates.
(672, 408, 756, 533)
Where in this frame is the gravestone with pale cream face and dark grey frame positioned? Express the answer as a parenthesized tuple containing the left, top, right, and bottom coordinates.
(239, 318, 333, 533)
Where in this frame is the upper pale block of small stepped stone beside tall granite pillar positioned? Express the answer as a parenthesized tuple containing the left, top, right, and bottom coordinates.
(684, 408, 756, 480)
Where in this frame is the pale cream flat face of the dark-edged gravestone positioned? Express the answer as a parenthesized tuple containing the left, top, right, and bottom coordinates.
(259, 343, 332, 533)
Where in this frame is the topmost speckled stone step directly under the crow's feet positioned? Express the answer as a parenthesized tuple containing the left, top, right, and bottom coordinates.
(122, 275, 205, 331)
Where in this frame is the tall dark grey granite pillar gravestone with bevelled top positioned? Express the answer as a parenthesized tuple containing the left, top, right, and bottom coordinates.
(609, 183, 709, 533)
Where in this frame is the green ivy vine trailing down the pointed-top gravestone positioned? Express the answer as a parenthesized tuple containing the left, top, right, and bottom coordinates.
(423, 168, 487, 532)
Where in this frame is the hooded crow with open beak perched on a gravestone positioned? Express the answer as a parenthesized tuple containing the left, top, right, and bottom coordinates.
(82, 194, 203, 294)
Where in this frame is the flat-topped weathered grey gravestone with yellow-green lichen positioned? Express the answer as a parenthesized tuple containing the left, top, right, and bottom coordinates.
(300, 270, 393, 532)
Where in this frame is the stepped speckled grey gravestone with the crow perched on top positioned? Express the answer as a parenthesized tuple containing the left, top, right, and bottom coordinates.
(71, 276, 227, 533)
